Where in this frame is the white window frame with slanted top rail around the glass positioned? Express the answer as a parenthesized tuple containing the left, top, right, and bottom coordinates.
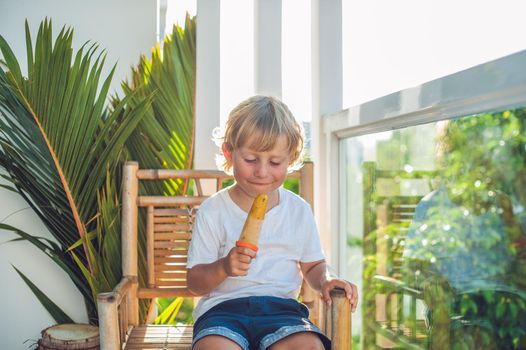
(319, 50, 526, 277)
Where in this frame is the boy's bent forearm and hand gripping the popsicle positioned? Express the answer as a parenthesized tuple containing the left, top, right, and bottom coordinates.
(187, 247, 256, 295)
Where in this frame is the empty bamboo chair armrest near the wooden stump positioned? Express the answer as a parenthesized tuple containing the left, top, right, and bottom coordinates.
(97, 276, 136, 350)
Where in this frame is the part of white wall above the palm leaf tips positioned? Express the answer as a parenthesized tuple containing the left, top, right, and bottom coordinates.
(0, 0, 157, 95)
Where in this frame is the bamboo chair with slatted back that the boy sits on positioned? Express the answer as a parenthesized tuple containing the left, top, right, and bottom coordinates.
(97, 162, 351, 350)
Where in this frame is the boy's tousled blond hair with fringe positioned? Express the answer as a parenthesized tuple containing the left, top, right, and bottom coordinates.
(214, 95, 304, 173)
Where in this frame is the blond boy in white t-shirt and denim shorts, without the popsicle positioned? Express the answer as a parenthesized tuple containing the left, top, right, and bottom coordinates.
(188, 96, 357, 350)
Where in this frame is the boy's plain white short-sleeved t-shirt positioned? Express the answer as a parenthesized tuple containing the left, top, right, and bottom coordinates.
(187, 188, 325, 320)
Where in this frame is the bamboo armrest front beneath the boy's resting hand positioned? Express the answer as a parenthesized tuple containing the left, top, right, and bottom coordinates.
(325, 288, 352, 350)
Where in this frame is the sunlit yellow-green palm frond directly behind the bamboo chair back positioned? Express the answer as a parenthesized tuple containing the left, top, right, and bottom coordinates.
(114, 16, 196, 194)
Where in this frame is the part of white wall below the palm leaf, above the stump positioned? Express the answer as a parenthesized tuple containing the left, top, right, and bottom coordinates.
(0, 179, 87, 350)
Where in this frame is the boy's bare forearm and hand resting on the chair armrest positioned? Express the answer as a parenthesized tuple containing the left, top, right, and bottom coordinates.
(300, 260, 358, 312)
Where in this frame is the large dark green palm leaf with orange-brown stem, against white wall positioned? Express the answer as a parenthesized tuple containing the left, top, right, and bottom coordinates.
(0, 20, 150, 316)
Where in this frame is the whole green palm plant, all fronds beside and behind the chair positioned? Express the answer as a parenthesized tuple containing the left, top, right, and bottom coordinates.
(0, 17, 195, 322)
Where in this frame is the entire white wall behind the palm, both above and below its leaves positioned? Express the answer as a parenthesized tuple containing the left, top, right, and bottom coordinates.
(0, 0, 157, 350)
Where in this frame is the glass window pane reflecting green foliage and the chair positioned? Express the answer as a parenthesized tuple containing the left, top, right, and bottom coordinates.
(340, 108, 526, 349)
